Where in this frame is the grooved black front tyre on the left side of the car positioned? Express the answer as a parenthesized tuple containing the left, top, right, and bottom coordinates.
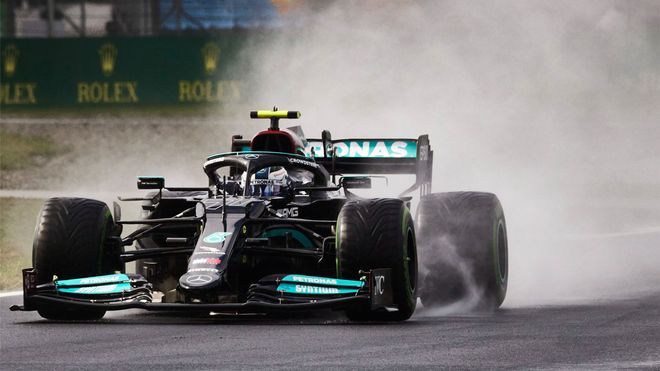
(32, 198, 122, 320)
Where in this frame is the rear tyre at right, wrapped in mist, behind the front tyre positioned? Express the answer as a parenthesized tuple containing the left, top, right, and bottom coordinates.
(416, 192, 508, 311)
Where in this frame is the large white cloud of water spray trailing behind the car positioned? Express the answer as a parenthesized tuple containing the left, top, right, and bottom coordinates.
(232, 0, 660, 306)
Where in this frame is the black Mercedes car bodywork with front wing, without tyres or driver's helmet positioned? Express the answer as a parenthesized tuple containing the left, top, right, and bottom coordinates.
(13, 129, 432, 312)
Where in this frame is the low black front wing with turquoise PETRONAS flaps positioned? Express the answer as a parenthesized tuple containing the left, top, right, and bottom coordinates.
(10, 268, 397, 313)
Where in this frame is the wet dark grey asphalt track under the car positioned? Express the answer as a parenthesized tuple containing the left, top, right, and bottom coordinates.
(0, 291, 660, 370)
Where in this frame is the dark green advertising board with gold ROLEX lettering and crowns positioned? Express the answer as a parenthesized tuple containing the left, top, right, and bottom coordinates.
(0, 35, 245, 108)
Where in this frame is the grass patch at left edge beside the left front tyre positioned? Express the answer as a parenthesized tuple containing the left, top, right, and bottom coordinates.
(0, 198, 43, 290)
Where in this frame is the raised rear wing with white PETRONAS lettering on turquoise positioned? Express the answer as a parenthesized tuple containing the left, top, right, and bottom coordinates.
(305, 135, 433, 195)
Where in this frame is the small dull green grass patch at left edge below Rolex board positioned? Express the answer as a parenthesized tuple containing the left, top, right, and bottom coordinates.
(0, 129, 60, 171)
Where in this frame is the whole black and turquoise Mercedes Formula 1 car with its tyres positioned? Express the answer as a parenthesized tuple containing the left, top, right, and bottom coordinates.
(11, 109, 507, 321)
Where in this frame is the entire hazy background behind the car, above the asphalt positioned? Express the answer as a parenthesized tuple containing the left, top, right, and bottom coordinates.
(0, 0, 660, 306)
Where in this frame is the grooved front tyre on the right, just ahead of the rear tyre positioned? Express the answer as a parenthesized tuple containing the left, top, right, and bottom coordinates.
(337, 199, 417, 321)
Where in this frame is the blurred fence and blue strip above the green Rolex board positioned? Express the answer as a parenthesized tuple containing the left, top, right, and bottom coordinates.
(2, 0, 318, 37)
